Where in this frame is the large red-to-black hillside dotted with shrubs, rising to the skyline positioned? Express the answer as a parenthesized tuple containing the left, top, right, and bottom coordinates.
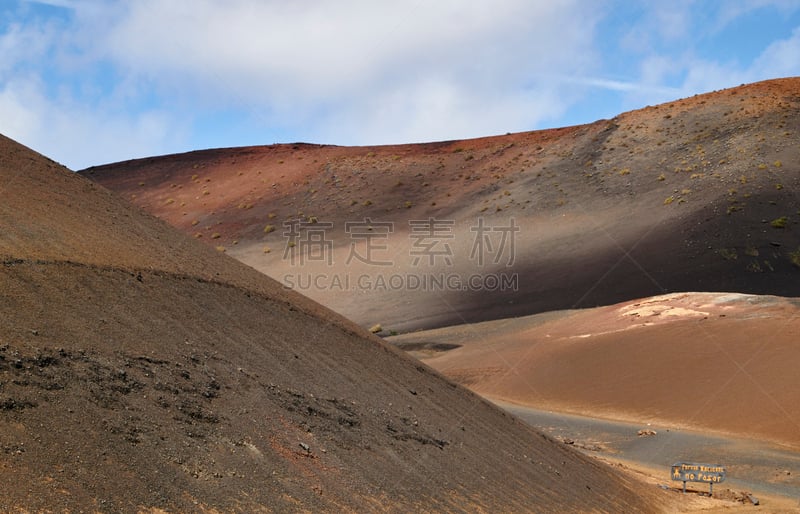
(84, 78, 800, 330)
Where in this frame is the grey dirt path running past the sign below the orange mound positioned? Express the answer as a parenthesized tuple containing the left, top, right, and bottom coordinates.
(495, 402, 800, 502)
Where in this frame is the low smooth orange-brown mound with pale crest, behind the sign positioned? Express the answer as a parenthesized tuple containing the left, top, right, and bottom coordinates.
(392, 293, 800, 449)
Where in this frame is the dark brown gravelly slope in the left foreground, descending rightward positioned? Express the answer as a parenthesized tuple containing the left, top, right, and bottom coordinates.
(0, 134, 660, 512)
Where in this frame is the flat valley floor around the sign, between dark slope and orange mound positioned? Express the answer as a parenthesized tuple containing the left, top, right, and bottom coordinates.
(494, 401, 800, 512)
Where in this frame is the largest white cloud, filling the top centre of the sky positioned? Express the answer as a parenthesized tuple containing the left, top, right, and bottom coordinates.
(86, 0, 597, 143)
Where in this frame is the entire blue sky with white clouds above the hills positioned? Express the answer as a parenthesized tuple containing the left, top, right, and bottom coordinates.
(0, 0, 800, 169)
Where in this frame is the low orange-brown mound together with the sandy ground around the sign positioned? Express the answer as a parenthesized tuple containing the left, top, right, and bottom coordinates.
(388, 293, 800, 512)
